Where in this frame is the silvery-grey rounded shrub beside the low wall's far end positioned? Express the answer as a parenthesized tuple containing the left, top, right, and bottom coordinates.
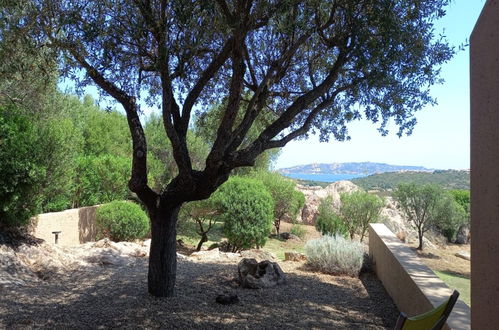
(305, 235, 364, 276)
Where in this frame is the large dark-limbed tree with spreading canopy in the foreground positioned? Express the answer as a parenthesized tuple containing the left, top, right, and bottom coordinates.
(22, 0, 453, 296)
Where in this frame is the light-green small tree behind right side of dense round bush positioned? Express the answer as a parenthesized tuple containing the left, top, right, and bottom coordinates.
(251, 171, 305, 234)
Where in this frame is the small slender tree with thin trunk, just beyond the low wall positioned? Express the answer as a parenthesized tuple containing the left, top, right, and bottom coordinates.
(393, 183, 445, 250)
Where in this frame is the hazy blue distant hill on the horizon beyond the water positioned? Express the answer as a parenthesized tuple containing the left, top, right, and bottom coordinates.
(279, 162, 432, 175)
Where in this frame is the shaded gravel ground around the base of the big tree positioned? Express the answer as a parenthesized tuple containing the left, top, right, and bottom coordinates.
(0, 257, 398, 329)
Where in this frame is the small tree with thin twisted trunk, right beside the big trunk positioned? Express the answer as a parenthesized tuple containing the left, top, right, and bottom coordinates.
(179, 199, 218, 251)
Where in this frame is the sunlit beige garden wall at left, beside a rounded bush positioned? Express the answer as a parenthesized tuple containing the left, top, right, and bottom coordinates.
(32, 206, 97, 246)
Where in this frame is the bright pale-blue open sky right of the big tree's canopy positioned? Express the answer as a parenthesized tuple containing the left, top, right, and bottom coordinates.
(274, 0, 485, 169)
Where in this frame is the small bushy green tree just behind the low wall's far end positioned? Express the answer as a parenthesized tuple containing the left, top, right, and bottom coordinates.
(339, 191, 385, 242)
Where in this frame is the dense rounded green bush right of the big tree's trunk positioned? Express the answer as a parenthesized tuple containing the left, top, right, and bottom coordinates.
(213, 177, 274, 251)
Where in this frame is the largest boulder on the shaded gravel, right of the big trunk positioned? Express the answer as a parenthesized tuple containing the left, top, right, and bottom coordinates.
(237, 258, 286, 289)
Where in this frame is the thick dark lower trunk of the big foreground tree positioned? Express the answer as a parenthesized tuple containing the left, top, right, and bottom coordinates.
(147, 206, 180, 297)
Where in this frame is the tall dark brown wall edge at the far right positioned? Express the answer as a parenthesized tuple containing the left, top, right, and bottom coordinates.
(470, 0, 499, 329)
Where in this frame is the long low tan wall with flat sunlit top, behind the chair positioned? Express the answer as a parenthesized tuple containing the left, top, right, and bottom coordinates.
(369, 223, 471, 329)
